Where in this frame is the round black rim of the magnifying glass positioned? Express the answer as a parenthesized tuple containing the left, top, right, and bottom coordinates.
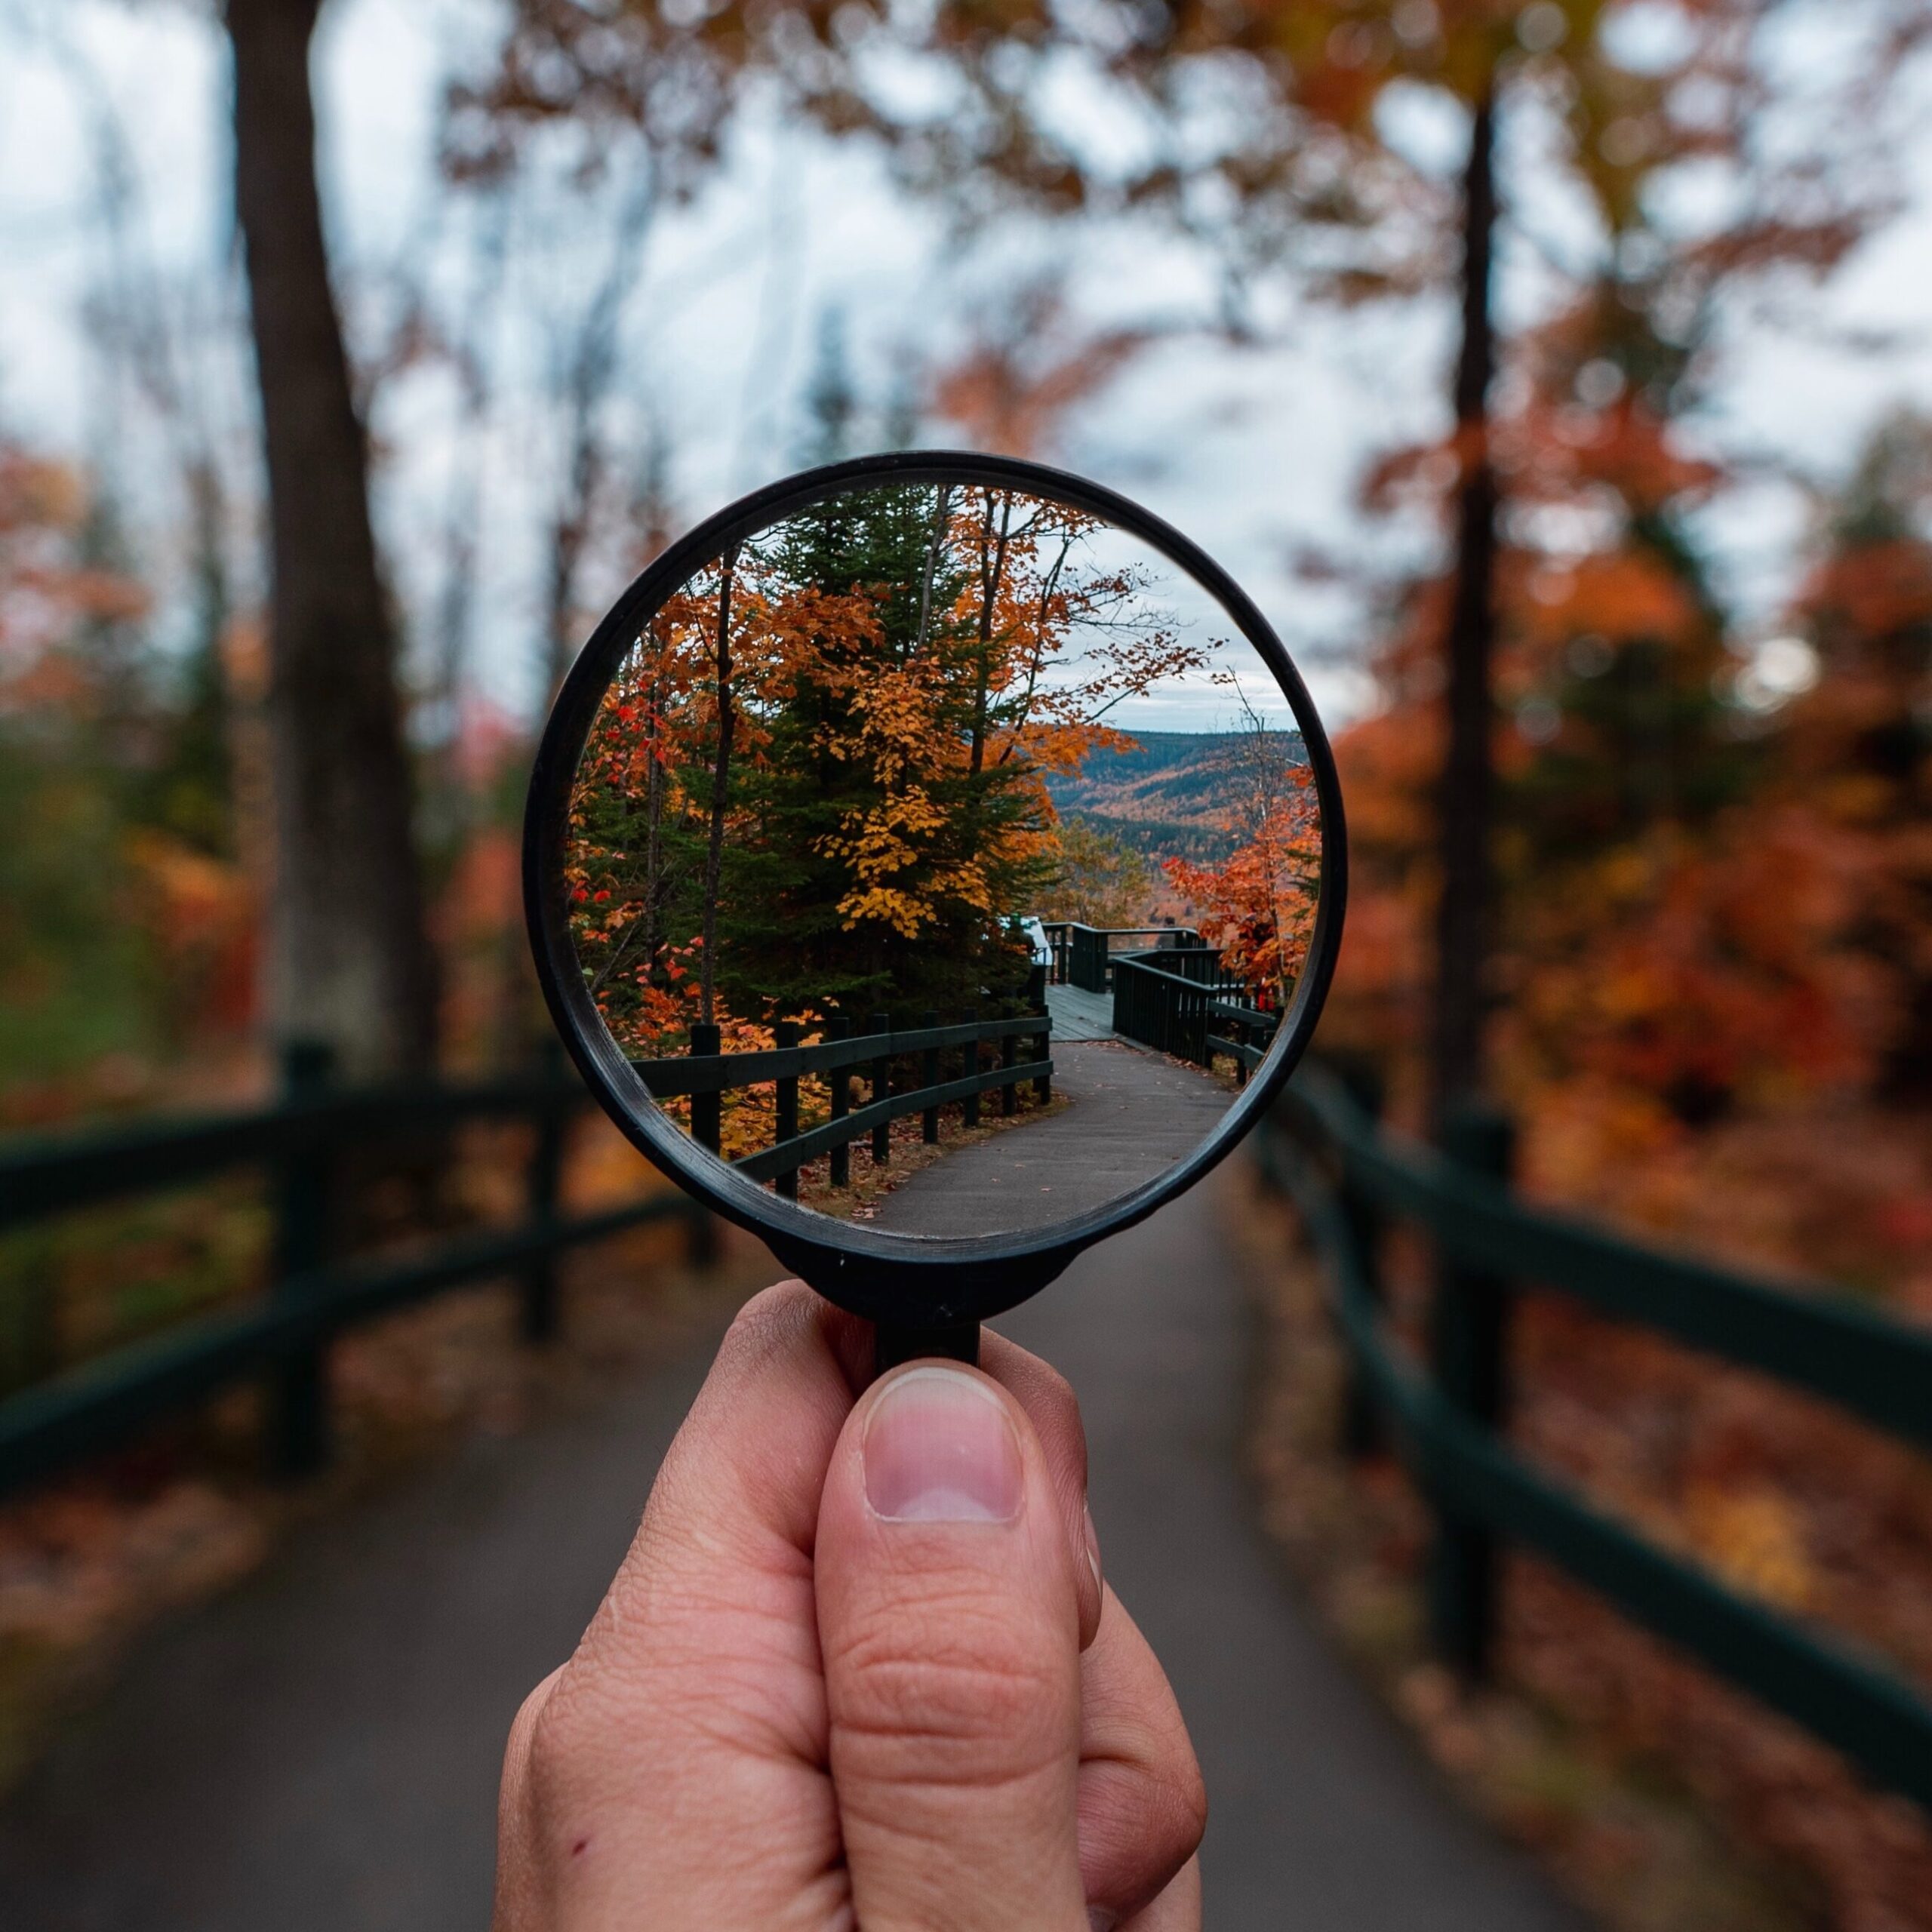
(524, 450, 1349, 1325)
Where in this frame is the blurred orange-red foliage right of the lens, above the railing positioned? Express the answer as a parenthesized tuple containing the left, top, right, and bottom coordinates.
(1329, 245, 1932, 1283)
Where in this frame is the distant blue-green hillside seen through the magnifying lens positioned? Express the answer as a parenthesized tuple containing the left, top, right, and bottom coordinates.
(1048, 731, 1308, 862)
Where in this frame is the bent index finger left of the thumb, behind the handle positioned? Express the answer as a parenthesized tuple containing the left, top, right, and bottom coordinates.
(503, 1283, 852, 1926)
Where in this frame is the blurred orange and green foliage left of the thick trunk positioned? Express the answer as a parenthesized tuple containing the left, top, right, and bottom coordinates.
(0, 445, 253, 1121)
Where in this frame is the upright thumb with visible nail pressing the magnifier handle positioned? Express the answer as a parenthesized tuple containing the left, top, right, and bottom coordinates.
(814, 1362, 1088, 1932)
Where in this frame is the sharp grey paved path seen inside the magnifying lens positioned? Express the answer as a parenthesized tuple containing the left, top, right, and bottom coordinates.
(872, 1035, 1235, 1235)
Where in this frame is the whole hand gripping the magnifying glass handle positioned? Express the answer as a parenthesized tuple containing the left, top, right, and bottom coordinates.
(494, 1281, 1204, 1932)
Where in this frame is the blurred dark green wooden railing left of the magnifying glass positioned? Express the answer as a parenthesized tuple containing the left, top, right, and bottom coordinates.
(0, 1048, 715, 1494)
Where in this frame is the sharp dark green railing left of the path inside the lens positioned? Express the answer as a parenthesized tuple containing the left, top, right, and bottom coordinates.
(632, 1012, 1053, 1198)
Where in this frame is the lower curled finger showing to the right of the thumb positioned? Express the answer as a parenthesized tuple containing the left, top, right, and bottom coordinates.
(1080, 1590, 1208, 1924)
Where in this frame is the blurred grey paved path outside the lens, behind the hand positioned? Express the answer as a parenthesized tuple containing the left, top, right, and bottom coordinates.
(0, 1183, 1580, 1932)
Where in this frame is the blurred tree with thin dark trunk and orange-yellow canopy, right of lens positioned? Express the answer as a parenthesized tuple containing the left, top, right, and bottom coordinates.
(981, 0, 1917, 1124)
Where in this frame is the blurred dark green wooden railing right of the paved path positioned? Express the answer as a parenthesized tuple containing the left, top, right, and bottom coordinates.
(1256, 1070, 1932, 1807)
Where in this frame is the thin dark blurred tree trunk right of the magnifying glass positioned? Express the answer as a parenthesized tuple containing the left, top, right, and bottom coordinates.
(1429, 94, 1497, 1132)
